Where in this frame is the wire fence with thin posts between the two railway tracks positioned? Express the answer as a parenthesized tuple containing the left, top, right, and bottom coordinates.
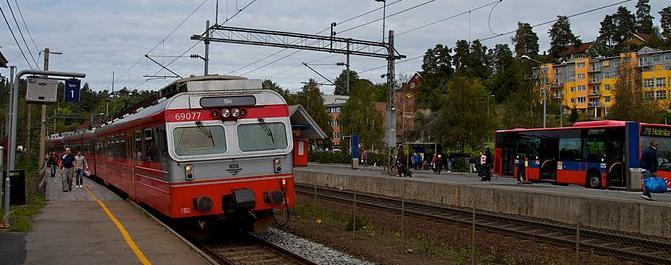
(296, 180, 671, 264)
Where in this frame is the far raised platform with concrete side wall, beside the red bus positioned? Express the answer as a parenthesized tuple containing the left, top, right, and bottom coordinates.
(294, 164, 671, 238)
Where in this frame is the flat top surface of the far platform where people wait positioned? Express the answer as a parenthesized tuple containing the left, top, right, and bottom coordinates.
(296, 163, 671, 204)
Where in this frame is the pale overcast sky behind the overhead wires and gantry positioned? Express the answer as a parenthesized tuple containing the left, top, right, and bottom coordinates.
(0, 0, 670, 93)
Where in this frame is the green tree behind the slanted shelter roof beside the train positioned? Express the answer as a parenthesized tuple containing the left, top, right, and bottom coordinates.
(295, 79, 333, 146)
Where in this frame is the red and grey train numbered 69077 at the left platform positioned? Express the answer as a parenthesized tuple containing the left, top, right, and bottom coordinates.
(47, 76, 295, 229)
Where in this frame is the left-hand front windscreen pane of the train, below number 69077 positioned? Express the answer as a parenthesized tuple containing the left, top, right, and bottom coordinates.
(173, 124, 226, 156)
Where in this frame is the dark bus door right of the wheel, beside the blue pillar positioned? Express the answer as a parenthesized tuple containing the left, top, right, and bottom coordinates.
(605, 128, 626, 187)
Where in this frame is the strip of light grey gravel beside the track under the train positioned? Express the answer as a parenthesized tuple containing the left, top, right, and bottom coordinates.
(259, 228, 374, 265)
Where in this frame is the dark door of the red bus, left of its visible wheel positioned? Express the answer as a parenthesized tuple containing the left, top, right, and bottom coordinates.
(540, 132, 559, 181)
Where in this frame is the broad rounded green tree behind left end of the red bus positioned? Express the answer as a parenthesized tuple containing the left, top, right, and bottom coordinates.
(433, 75, 494, 151)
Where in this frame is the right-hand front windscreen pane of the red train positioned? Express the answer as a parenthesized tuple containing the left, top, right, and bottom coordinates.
(238, 120, 287, 152)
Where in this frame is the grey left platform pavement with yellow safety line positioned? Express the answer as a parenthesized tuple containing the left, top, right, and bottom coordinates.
(19, 172, 207, 265)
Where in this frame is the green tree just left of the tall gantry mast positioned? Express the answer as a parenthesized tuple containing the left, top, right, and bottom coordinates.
(339, 80, 383, 150)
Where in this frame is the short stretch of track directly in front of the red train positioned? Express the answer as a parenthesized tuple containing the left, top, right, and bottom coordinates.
(196, 234, 316, 265)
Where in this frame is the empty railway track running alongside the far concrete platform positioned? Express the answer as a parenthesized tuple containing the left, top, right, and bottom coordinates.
(295, 184, 671, 264)
